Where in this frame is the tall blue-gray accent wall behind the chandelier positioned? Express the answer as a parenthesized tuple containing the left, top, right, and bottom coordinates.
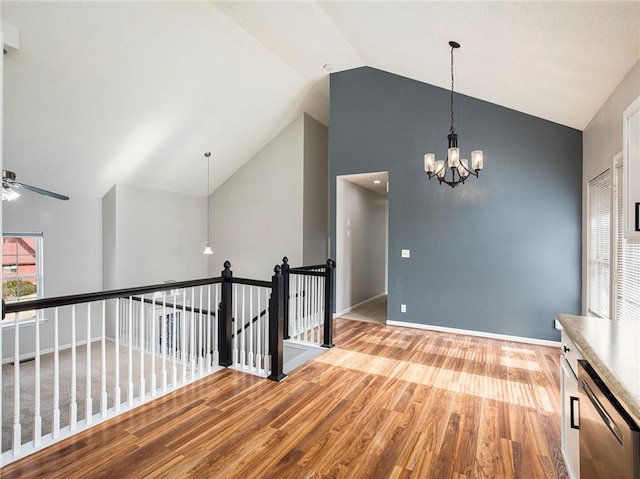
(329, 67, 582, 340)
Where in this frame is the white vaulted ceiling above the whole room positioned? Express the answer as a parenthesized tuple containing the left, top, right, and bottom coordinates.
(1, 0, 640, 198)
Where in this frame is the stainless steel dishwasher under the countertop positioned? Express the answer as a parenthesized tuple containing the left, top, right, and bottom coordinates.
(578, 360, 640, 479)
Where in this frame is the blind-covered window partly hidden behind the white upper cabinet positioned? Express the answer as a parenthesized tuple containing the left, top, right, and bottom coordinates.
(613, 155, 640, 322)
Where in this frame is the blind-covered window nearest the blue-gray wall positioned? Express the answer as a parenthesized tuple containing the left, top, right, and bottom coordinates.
(587, 170, 611, 318)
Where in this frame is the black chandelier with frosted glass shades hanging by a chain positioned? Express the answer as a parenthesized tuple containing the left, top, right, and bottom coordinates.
(424, 41, 484, 188)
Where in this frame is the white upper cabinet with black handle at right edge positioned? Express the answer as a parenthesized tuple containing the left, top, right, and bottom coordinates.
(622, 97, 640, 241)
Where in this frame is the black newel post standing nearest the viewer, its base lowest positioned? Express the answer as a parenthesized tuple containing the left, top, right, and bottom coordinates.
(268, 265, 287, 381)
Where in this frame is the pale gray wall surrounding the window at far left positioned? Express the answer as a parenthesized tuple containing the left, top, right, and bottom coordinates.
(2, 191, 102, 358)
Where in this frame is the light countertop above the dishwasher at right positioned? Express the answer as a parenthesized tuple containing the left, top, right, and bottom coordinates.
(558, 314, 640, 424)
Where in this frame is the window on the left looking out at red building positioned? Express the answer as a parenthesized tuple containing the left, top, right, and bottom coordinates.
(2, 233, 43, 321)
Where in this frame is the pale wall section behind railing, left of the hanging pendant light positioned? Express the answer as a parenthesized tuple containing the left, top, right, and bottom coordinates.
(103, 185, 207, 289)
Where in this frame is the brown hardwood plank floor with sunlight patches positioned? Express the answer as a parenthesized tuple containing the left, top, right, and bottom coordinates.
(0, 319, 568, 479)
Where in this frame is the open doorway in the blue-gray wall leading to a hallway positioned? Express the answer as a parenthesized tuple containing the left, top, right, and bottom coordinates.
(335, 171, 389, 324)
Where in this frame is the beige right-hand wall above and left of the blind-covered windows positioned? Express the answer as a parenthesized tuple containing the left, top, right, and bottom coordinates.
(582, 61, 640, 314)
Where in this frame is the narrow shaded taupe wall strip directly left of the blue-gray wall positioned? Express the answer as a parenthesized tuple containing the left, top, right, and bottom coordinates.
(302, 114, 329, 266)
